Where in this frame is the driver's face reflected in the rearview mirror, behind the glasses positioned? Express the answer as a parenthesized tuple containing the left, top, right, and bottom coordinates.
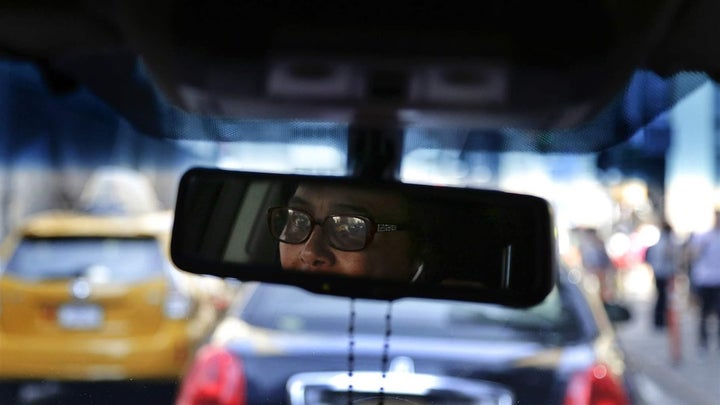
(279, 185, 419, 280)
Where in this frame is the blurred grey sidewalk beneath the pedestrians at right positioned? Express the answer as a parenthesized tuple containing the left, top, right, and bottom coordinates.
(616, 270, 720, 405)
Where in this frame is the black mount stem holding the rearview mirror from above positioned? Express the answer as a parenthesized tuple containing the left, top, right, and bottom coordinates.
(348, 123, 403, 180)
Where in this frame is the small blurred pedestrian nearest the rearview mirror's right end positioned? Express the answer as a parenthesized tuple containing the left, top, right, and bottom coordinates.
(580, 228, 615, 302)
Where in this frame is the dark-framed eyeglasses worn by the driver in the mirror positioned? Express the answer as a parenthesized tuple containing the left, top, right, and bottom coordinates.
(268, 207, 406, 251)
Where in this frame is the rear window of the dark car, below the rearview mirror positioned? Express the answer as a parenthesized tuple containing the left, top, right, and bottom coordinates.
(239, 284, 585, 344)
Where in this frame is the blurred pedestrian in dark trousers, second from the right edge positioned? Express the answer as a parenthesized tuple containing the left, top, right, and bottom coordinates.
(645, 222, 682, 329)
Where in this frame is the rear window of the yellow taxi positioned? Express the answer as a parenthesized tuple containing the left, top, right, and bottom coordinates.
(6, 237, 166, 283)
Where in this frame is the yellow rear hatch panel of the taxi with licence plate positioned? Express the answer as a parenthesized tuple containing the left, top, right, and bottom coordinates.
(0, 276, 167, 338)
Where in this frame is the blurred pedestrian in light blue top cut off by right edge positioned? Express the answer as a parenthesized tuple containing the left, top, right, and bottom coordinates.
(690, 211, 720, 352)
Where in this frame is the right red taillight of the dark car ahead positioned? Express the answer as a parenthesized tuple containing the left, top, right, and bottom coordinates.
(565, 364, 630, 405)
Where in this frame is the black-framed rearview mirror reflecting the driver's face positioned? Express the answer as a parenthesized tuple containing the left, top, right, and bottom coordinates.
(171, 168, 556, 306)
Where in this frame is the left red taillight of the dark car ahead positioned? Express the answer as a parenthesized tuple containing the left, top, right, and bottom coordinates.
(176, 346, 246, 405)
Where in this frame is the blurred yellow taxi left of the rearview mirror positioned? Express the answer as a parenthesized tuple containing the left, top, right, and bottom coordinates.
(0, 211, 223, 381)
